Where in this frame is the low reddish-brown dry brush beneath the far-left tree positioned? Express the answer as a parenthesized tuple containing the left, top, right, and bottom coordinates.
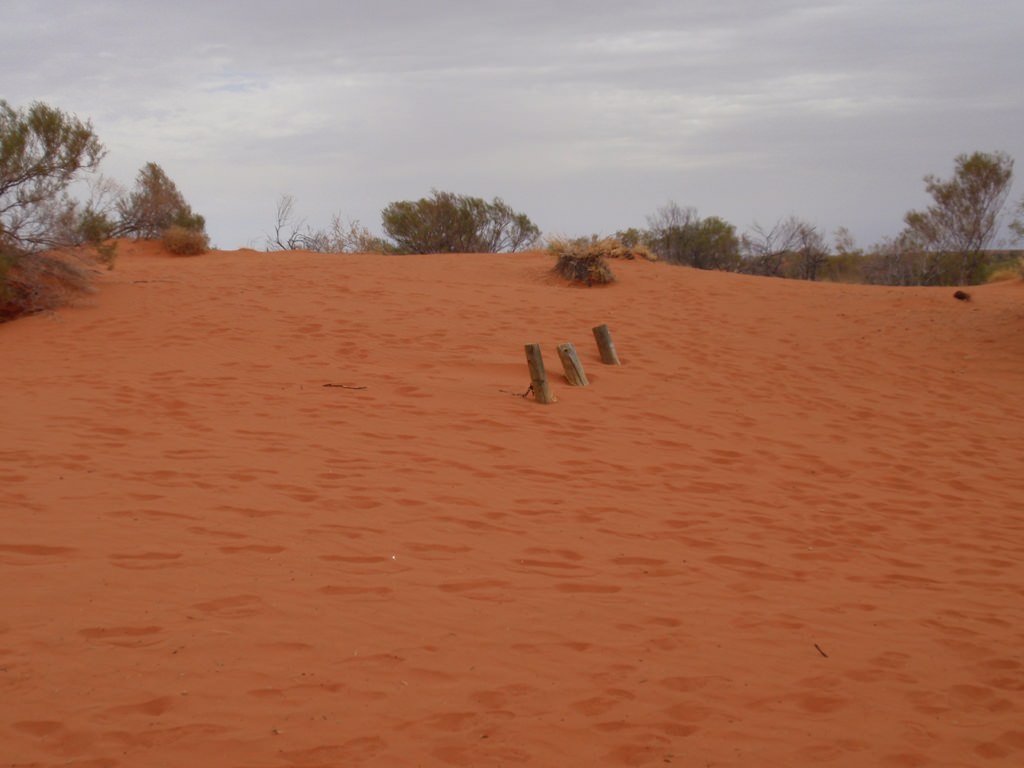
(0, 253, 92, 323)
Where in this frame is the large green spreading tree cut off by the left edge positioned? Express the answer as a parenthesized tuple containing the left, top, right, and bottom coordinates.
(0, 99, 105, 254)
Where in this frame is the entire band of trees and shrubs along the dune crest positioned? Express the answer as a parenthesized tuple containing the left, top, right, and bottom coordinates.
(0, 99, 1024, 321)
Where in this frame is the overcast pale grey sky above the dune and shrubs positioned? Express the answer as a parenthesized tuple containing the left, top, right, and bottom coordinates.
(0, 0, 1024, 249)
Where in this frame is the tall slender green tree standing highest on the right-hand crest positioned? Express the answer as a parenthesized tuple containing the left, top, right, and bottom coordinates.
(904, 152, 1014, 284)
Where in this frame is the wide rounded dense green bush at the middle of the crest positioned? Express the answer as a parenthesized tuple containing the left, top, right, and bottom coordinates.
(381, 189, 541, 253)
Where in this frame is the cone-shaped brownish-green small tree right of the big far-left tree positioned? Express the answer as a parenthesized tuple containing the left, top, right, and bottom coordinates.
(117, 163, 206, 240)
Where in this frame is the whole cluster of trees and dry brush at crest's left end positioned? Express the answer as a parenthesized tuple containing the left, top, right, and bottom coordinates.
(0, 99, 208, 322)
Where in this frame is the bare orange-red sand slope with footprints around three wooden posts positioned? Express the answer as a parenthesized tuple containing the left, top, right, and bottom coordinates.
(6, 245, 1024, 768)
